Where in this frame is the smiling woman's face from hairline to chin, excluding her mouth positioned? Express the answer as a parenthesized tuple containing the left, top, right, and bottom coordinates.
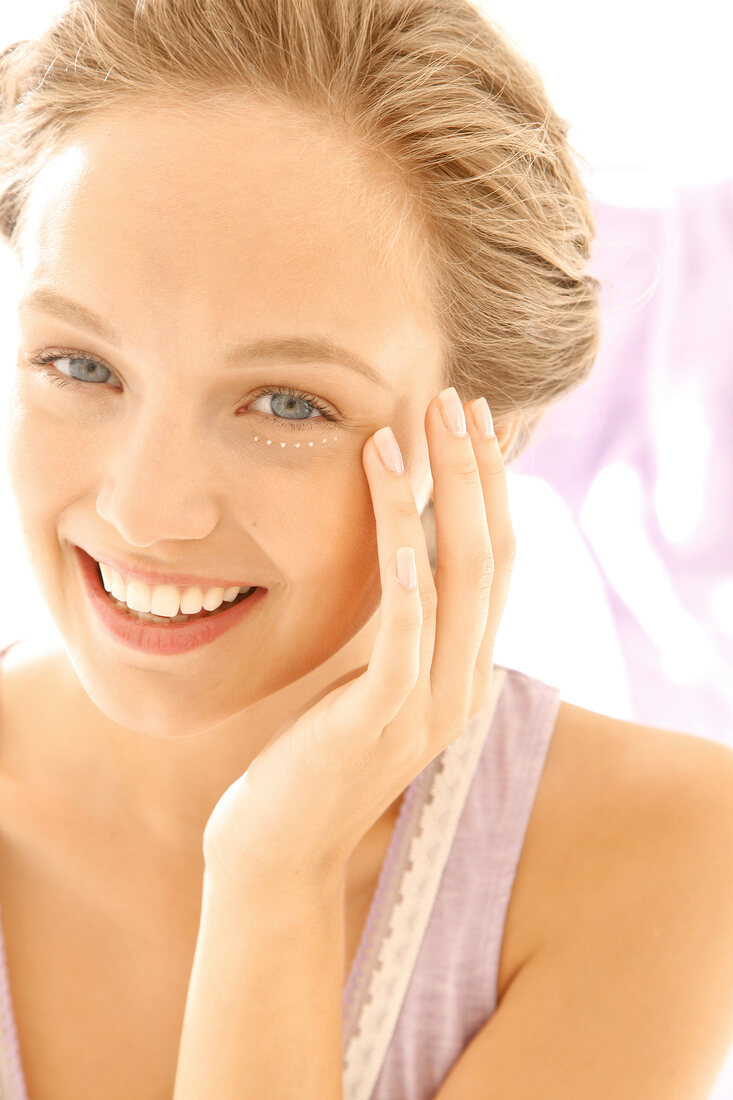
(9, 94, 440, 734)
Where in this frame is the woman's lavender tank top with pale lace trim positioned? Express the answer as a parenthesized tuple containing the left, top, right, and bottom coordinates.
(0, 647, 561, 1100)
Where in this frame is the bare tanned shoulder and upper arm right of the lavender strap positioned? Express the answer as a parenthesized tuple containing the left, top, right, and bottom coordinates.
(436, 704, 733, 1100)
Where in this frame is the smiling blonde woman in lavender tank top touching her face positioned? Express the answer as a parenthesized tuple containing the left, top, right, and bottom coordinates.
(0, 0, 733, 1100)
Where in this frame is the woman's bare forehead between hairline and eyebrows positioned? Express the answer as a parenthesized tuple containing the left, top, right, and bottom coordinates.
(21, 94, 437, 389)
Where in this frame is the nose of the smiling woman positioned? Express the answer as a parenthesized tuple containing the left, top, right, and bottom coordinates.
(97, 403, 222, 547)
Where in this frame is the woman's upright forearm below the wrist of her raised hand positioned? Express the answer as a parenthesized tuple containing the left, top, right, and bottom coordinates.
(173, 866, 344, 1100)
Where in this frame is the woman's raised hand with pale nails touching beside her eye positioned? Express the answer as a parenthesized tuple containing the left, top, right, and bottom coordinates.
(204, 391, 515, 891)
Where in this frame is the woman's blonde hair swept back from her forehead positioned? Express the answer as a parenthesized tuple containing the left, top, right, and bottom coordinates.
(0, 0, 600, 462)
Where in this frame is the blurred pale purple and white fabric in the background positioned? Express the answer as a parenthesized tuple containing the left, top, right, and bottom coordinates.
(512, 180, 733, 746)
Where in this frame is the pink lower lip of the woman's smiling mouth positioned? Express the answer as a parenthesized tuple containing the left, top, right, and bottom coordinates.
(74, 547, 267, 656)
